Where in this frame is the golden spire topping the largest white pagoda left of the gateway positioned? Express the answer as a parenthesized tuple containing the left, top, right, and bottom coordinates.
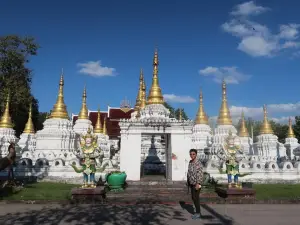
(49, 71, 69, 119)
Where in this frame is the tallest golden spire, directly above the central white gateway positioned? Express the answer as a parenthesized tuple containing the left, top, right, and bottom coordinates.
(147, 49, 164, 105)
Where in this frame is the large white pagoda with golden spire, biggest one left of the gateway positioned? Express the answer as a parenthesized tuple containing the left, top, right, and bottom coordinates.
(30, 74, 78, 168)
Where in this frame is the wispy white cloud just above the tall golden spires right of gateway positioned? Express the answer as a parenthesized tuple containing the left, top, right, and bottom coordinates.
(199, 66, 250, 84)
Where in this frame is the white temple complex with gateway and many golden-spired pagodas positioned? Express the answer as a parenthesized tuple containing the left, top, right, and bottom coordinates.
(0, 50, 300, 183)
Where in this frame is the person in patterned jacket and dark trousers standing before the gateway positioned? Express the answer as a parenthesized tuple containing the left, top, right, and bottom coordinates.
(187, 149, 203, 220)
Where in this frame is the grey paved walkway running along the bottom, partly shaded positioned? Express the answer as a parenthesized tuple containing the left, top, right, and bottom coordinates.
(0, 204, 300, 225)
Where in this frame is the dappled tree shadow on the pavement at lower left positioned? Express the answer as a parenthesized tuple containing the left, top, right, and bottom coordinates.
(0, 204, 187, 225)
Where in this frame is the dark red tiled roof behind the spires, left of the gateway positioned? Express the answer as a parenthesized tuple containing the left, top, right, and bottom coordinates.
(73, 108, 134, 137)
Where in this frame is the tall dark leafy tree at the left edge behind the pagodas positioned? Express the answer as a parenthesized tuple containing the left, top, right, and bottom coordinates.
(0, 35, 39, 136)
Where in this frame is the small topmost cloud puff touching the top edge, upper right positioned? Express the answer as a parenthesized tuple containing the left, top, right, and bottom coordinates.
(231, 1, 269, 16)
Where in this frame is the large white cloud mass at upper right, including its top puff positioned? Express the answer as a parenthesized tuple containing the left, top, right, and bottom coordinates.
(221, 1, 300, 57)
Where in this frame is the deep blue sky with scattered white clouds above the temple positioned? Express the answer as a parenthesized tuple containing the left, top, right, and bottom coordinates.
(0, 0, 300, 122)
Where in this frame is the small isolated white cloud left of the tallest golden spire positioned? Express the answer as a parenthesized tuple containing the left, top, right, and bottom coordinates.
(77, 60, 116, 77)
